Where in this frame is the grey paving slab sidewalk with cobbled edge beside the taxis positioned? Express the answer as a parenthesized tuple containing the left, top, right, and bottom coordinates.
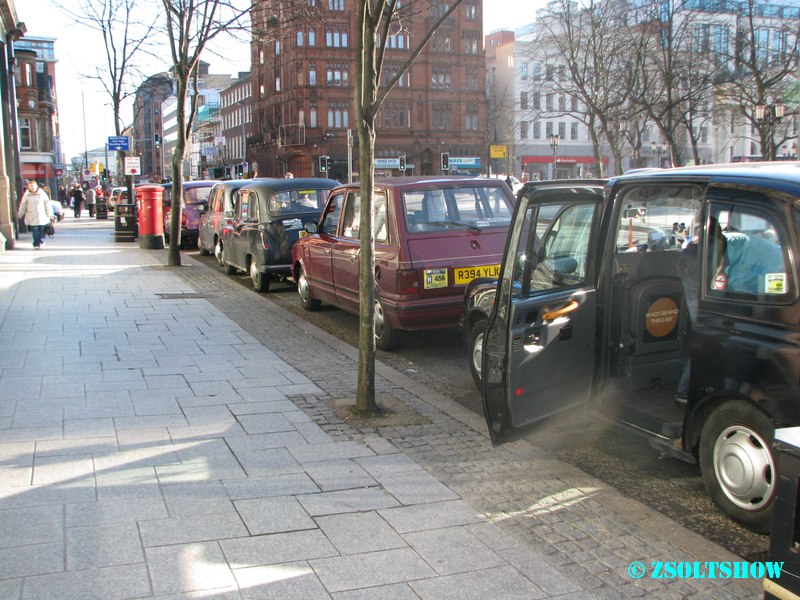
(0, 219, 759, 599)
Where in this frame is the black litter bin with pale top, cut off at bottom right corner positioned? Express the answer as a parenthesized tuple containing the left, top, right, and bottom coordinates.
(764, 427, 800, 600)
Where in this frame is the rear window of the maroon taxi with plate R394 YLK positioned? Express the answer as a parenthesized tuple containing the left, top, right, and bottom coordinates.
(403, 186, 511, 232)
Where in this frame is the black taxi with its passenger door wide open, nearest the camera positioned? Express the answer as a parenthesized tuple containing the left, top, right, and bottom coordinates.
(478, 163, 800, 531)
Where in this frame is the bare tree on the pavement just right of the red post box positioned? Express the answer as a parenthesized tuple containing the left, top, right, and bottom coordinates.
(161, 0, 249, 267)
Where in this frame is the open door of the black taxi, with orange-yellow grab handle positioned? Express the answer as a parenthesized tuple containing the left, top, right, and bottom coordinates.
(482, 181, 604, 444)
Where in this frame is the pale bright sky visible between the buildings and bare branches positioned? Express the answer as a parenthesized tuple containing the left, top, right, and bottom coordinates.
(15, 0, 545, 162)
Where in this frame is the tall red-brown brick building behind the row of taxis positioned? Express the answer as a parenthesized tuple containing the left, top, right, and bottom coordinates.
(248, 0, 486, 180)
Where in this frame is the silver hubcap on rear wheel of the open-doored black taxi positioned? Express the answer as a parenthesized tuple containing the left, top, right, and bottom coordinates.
(714, 425, 775, 510)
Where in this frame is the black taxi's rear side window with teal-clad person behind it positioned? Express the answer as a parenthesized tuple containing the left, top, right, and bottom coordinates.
(704, 203, 795, 302)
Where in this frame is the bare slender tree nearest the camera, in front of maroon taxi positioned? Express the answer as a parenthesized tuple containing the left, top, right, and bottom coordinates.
(355, 0, 462, 412)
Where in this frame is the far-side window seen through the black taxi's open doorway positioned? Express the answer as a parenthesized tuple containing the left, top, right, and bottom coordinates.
(616, 184, 703, 253)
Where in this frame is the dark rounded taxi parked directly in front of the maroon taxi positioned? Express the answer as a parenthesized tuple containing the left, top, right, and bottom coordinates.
(221, 178, 338, 292)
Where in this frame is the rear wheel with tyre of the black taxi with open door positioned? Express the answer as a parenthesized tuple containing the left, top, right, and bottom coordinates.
(700, 400, 777, 532)
